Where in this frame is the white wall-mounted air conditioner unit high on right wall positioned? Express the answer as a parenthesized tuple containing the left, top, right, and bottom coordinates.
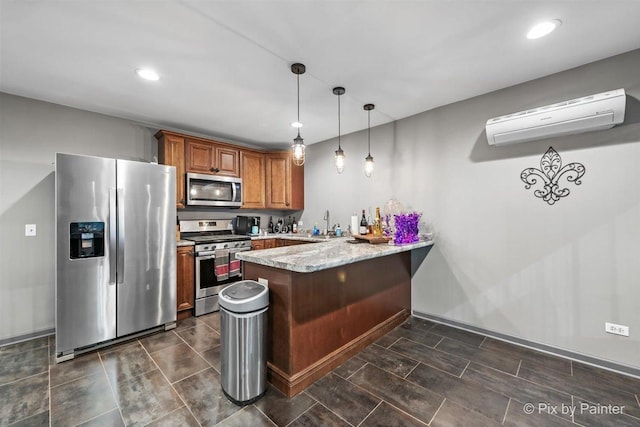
(486, 89, 626, 145)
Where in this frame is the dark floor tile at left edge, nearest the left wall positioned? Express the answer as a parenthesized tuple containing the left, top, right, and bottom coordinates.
(0, 343, 49, 385)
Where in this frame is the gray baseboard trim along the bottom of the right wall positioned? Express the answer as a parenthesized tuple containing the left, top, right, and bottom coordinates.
(412, 310, 640, 378)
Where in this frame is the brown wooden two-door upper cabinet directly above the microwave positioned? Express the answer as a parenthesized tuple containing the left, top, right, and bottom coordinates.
(185, 138, 240, 177)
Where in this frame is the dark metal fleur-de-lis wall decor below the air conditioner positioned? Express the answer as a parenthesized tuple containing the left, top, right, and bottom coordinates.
(520, 147, 586, 205)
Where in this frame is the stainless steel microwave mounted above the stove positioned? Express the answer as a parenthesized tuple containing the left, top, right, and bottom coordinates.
(187, 173, 242, 208)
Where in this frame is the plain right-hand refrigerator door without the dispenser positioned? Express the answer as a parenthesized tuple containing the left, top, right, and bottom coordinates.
(116, 160, 176, 337)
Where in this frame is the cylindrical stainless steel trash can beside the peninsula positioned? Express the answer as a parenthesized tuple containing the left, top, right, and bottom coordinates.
(218, 280, 269, 405)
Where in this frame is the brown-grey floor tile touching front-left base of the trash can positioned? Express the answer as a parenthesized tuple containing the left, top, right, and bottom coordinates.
(173, 369, 240, 426)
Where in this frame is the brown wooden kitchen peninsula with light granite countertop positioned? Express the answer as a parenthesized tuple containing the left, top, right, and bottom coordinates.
(237, 237, 433, 396)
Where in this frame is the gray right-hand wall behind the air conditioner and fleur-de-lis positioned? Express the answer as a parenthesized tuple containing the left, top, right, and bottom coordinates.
(303, 50, 640, 368)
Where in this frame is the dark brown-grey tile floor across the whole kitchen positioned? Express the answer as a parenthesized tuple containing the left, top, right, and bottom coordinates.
(0, 314, 640, 426)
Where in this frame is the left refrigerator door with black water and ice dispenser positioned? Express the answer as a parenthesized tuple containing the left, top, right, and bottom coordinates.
(55, 153, 116, 354)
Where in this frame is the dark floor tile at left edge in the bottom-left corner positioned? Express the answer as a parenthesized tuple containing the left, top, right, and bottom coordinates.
(0, 372, 49, 425)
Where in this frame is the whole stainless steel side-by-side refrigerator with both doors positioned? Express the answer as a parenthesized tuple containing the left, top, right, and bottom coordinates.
(55, 153, 176, 361)
